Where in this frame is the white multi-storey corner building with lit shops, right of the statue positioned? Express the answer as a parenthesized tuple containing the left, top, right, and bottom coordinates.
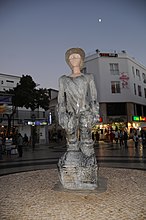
(84, 50, 146, 135)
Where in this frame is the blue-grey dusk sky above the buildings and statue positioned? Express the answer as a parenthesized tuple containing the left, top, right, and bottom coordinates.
(0, 0, 146, 89)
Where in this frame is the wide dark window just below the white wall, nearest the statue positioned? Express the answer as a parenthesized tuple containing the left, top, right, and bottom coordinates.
(106, 103, 127, 116)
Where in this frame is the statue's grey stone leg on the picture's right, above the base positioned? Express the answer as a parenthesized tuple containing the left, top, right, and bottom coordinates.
(79, 111, 94, 157)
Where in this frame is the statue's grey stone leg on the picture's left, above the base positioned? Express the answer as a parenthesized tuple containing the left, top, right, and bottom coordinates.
(66, 115, 79, 151)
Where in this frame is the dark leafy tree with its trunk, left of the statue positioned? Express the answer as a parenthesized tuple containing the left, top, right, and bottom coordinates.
(5, 75, 50, 135)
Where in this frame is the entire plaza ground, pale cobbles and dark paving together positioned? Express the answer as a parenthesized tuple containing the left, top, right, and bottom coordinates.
(0, 142, 146, 220)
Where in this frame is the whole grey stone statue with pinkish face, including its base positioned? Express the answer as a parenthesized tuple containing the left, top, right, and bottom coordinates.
(58, 48, 99, 189)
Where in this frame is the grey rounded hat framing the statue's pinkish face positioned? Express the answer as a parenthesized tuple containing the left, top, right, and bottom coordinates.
(65, 47, 85, 69)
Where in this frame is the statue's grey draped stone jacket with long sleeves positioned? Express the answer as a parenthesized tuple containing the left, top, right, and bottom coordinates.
(58, 73, 99, 128)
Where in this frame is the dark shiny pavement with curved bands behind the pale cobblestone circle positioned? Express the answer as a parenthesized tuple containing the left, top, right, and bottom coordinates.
(0, 140, 146, 175)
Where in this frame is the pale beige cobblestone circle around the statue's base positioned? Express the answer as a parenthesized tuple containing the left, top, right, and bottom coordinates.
(0, 167, 146, 220)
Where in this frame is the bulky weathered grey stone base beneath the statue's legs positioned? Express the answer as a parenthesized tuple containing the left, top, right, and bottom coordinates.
(58, 151, 97, 190)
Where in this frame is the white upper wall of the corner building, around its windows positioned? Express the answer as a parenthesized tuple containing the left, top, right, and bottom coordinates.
(85, 53, 146, 105)
